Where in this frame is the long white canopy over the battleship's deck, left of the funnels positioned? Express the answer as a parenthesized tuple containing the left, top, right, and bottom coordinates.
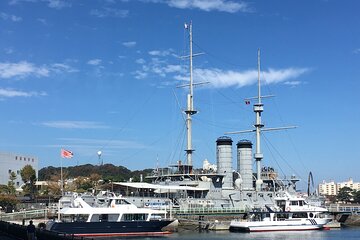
(114, 182, 209, 191)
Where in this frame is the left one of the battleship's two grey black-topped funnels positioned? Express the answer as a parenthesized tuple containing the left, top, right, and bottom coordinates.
(216, 137, 233, 189)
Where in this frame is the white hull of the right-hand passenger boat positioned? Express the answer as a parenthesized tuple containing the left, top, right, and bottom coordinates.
(230, 219, 330, 232)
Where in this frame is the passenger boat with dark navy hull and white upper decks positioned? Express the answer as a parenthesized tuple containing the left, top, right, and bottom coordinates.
(46, 196, 173, 237)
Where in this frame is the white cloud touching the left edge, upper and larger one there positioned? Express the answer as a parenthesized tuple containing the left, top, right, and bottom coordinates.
(0, 61, 49, 78)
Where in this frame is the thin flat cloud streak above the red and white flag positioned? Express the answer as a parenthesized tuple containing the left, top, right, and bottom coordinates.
(41, 121, 109, 129)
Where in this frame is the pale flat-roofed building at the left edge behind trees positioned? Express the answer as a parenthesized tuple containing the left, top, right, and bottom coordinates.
(0, 152, 39, 189)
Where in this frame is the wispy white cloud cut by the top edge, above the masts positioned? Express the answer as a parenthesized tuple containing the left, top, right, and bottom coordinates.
(143, 0, 250, 13)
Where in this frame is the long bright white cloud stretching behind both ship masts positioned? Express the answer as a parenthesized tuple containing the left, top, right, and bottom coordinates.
(191, 68, 309, 88)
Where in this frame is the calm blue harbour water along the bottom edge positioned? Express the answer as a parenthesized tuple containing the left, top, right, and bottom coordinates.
(95, 227, 360, 240)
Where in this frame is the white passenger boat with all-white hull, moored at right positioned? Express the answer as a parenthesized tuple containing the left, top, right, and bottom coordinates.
(229, 195, 332, 232)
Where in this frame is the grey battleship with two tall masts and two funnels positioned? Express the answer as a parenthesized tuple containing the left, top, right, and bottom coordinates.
(108, 23, 306, 209)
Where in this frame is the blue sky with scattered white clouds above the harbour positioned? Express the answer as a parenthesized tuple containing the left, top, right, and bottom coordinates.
(0, 0, 360, 188)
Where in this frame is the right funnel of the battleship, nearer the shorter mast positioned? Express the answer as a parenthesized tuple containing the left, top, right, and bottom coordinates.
(236, 140, 253, 190)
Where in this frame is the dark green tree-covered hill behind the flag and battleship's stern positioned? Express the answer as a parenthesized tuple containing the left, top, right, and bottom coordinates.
(38, 164, 153, 182)
